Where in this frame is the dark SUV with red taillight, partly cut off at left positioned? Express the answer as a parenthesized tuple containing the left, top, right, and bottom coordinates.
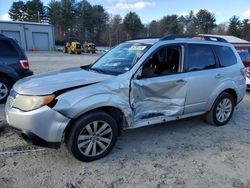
(0, 34, 33, 103)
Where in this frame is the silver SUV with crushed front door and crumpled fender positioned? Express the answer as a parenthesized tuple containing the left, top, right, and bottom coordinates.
(5, 35, 246, 161)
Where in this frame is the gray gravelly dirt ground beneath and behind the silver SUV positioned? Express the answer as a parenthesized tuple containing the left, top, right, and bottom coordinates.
(0, 53, 250, 188)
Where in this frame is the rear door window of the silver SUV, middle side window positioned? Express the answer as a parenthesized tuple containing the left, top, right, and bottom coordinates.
(186, 44, 216, 71)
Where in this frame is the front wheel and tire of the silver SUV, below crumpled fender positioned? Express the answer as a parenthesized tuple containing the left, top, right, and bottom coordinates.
(66, 112, 118, 162)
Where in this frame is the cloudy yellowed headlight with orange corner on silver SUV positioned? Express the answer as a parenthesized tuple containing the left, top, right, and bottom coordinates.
(12, 95, 55, 111)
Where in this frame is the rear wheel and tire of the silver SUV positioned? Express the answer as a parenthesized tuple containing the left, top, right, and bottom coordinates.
(205, 92, 235, 126)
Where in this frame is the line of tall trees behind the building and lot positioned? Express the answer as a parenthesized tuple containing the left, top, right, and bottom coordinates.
(9, 0, 250, 46)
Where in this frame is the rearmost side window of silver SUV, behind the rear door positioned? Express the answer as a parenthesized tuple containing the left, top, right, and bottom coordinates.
(214, 46, 237, 67)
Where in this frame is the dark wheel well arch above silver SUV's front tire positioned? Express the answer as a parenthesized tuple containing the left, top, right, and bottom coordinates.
(65, 106, 124, 140)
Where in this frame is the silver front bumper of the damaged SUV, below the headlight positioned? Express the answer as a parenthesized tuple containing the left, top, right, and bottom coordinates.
(5, 97, 70, 148)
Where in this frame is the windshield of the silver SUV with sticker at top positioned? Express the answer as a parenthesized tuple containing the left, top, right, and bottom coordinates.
(89, 43, 151, 75)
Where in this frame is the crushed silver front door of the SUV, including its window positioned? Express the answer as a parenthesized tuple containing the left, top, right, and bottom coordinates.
(130, 45, 187, 127)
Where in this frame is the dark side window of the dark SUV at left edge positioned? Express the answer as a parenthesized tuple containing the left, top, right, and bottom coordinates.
(0, 40, 18, 57)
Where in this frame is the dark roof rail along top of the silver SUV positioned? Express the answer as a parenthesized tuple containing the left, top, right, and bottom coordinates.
(161, 34, 228, 43)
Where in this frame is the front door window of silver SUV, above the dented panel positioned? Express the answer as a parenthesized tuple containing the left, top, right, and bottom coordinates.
(141, 46, 181, 78)
